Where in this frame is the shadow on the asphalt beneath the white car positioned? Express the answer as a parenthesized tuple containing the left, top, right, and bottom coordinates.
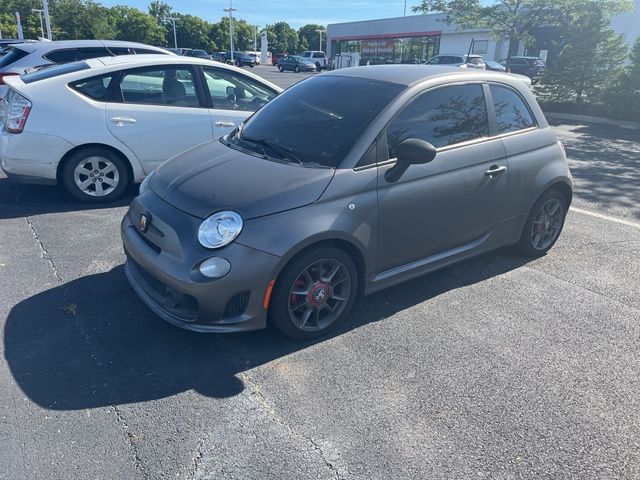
(0, 172, 138, 220)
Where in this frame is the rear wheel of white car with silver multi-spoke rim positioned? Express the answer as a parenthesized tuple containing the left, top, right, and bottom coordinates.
(62, 147, 131, 203)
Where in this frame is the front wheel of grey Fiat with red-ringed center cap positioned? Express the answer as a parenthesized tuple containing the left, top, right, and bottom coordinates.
(269, 247, 359, 340)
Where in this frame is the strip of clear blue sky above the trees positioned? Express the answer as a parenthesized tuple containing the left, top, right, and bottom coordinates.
(100, 0, 419, 29)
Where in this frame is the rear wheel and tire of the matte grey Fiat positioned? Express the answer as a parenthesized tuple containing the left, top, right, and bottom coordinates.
(516, 190, 567, 257)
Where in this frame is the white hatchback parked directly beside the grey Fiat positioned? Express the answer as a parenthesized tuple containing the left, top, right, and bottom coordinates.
(0, 55, 281, 203)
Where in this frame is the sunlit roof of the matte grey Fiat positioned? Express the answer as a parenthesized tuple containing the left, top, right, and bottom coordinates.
(321, 65, 520, 86)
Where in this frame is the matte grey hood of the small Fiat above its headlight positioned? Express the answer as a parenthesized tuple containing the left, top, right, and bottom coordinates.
(149, 140, 334, 220)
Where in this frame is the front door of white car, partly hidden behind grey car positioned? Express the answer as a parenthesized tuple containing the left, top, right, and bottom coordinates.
(202, 66, 277, 138)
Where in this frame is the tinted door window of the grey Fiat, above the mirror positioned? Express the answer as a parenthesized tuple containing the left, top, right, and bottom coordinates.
(387, 84, 489, 158)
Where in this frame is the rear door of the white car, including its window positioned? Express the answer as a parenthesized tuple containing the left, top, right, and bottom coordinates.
(106, 65, 213, 173)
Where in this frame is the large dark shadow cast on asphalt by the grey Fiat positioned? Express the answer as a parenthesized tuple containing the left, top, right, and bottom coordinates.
(4, 250, 528, 410)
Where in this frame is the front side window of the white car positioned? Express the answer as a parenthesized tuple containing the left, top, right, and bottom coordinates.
(203, 67, 277, 112)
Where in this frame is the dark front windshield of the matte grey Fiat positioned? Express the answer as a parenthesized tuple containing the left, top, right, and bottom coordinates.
(228, 76, 405, 168)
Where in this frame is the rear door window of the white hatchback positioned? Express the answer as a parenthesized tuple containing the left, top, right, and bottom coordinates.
(120, 66, 200, 107)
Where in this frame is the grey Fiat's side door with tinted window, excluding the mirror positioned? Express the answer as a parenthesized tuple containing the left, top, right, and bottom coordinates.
(378, 84, 508, 272)
